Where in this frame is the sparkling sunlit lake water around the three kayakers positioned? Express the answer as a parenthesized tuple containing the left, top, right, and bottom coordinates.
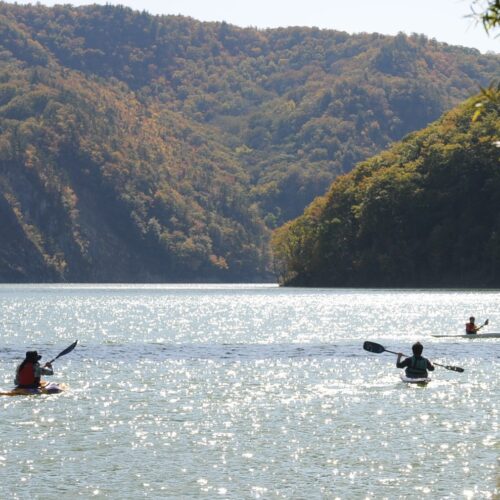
(0, 285, 500, 499)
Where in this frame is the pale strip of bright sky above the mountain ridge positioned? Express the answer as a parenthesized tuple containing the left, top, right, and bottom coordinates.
(4, 0, 500, 53)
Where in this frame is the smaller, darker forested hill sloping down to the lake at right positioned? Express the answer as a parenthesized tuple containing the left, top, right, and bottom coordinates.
(273, 95, 500, 287)
